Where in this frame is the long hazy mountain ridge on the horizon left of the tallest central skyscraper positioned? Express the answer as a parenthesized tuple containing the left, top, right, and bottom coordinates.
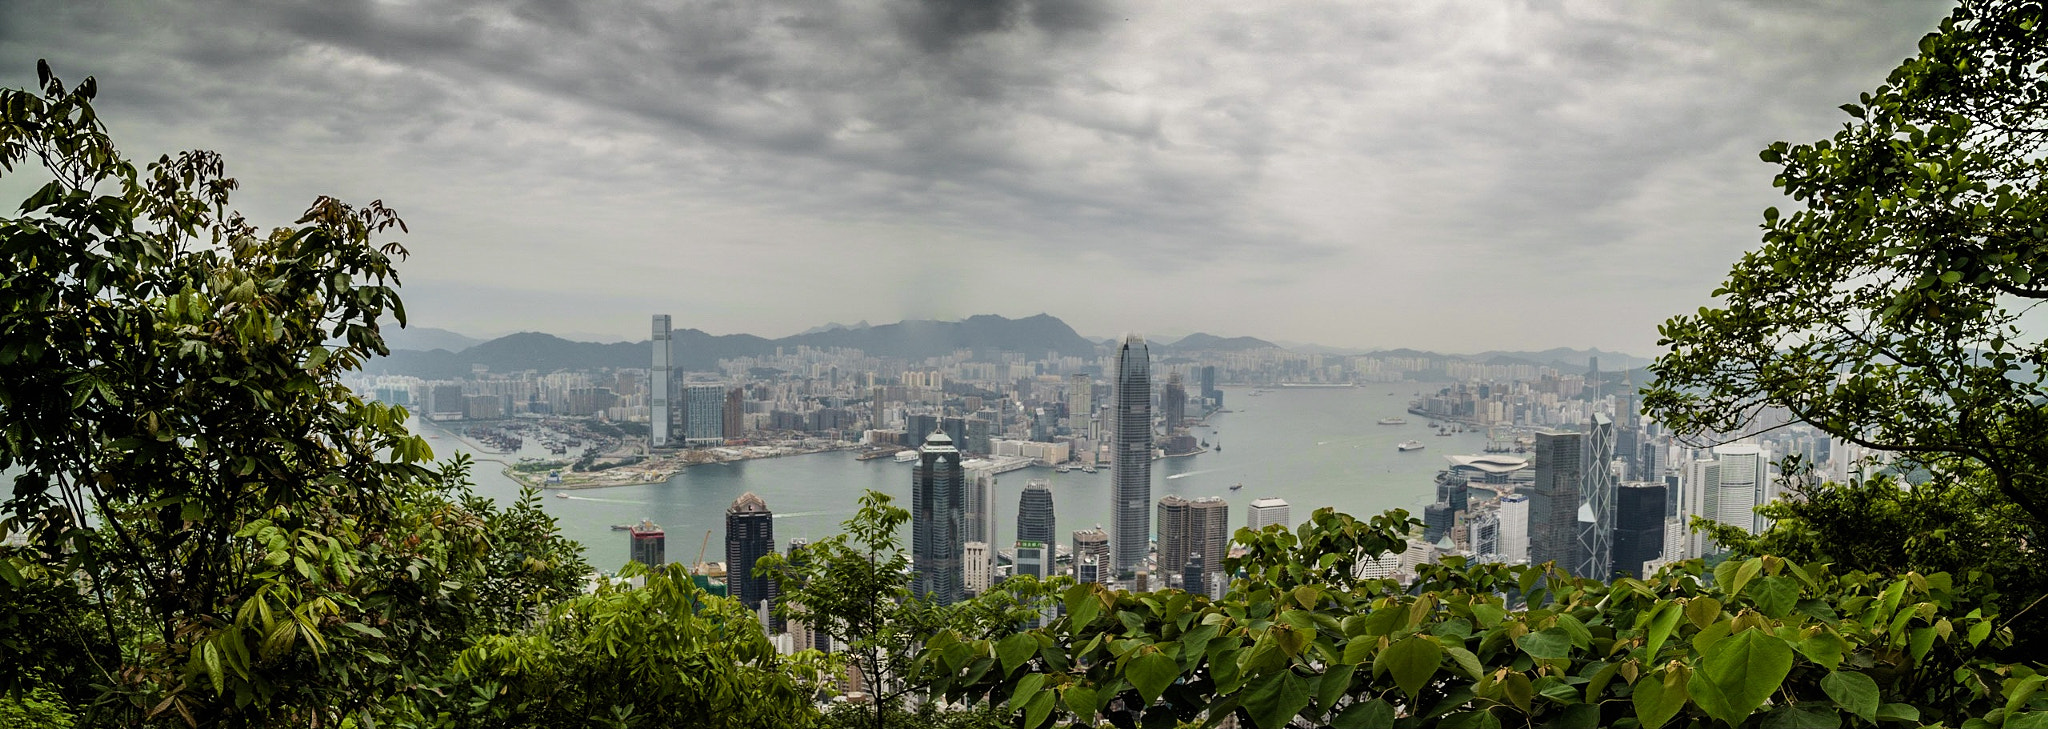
(365, 313, 1096, 379)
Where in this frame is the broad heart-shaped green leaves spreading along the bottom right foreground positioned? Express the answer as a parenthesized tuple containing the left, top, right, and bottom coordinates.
(937, 514, 2048, 729)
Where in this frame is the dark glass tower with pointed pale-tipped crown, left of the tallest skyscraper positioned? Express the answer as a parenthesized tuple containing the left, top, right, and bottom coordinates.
(909, 430, 967, 604)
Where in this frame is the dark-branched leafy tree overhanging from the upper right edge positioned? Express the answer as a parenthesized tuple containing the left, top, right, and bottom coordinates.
(1642, 0, 2048, 532)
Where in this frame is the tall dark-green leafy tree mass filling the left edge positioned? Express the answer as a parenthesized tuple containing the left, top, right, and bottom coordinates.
(0, 66, 586, 727)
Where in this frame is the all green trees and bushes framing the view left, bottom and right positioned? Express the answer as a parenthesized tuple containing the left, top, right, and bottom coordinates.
(12, 2, 2048, 729)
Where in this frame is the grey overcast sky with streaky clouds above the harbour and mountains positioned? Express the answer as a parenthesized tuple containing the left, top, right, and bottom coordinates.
(0, 0, 1948, 354)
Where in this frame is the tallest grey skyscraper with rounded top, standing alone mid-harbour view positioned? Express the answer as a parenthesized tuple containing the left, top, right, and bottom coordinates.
(1110, 334, 1151, 575)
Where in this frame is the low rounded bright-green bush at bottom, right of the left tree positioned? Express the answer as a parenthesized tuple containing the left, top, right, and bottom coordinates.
(444, 563, 829, 729)
